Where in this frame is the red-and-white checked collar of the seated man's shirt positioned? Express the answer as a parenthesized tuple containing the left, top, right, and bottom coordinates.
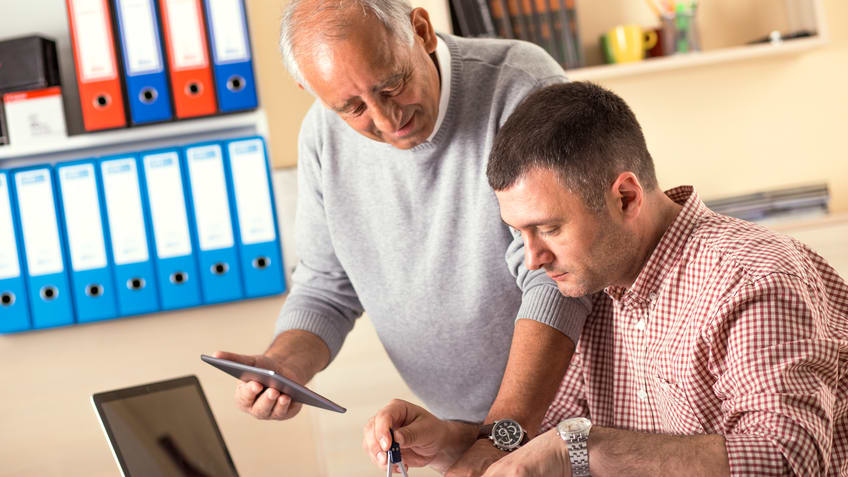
(604, 186, 709, 301)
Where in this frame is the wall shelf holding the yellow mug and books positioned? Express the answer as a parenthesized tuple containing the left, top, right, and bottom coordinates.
(565, 36, 827, 81)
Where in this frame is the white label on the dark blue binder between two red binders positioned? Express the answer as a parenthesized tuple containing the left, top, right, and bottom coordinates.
(118, 0, 162, 76)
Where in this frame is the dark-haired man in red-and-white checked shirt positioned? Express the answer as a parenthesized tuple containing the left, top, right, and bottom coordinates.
(373, 83, 848, 477)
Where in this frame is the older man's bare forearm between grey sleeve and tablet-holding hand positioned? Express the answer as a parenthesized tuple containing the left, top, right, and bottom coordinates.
(265, 330, 330, 384)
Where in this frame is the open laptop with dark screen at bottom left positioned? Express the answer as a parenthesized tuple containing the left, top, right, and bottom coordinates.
(91, 376, 238, 477)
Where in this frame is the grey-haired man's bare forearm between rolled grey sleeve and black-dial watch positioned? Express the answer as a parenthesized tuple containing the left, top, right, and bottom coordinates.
(486, 319, 574, 437)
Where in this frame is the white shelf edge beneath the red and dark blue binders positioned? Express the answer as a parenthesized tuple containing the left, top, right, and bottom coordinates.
(0, 109, 267, 162)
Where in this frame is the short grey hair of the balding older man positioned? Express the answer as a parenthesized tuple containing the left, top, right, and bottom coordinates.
(280, 0, 414, 92)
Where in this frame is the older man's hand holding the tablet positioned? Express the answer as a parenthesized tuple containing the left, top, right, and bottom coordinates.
(213, 351, 308, 421)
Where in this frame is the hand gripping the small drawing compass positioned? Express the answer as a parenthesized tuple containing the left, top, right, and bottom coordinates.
(362, 399, 477, 472)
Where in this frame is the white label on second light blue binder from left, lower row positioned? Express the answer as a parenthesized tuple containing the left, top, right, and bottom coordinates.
(15, 169, 65, 276)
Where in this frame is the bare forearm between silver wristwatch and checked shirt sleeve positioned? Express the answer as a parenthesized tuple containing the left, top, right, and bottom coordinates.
(588, 427, 730, 477)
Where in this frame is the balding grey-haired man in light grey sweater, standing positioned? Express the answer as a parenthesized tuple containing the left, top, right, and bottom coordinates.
(217, 0, 588, 474)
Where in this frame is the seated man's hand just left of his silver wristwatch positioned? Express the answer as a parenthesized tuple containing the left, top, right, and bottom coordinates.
(483, 429, 571, 477)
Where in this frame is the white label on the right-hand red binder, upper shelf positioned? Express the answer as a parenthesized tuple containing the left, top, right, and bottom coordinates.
(165, 0, 208, 70)
